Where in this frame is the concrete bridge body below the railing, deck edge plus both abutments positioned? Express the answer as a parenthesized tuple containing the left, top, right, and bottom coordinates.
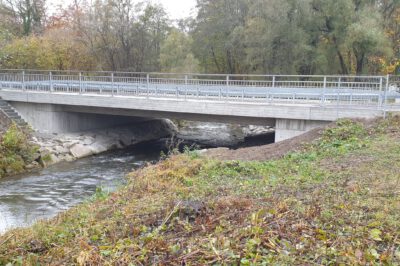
(0, 90, 383, 141)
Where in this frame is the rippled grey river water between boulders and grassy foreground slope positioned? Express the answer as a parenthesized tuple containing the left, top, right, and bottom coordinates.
(0, 145, 160, 233)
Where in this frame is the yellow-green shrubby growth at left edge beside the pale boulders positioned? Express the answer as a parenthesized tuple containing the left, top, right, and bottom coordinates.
(0, 124, 37, 178)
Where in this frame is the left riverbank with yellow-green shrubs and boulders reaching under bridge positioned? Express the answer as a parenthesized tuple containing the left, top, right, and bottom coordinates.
(0, 118, 176, 178)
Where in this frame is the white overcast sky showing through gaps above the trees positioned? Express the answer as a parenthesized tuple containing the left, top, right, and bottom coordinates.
(46, 0, 196, 19)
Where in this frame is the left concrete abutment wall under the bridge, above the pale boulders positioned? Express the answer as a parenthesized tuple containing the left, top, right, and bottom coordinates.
(10, 102, 144, 133)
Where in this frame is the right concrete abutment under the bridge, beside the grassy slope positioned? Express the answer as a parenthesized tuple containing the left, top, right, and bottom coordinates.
(275, 119, 329, 142)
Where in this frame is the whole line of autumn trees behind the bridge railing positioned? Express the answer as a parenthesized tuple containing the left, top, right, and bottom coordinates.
(0, 0, 400, 74)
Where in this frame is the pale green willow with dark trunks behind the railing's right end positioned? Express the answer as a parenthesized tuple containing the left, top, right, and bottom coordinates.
(313, 0, 390, 74)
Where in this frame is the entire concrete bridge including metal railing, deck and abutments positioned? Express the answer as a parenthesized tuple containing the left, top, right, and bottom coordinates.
(0, 70, 400, 141)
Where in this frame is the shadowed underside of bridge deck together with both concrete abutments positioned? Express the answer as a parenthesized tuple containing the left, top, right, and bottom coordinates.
(10, 102, 328, 142)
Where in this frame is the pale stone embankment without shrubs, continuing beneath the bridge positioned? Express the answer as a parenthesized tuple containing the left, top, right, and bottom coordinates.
(28, 120, 273, 168)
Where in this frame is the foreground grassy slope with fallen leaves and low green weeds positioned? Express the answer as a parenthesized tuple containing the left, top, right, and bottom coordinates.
(0, 117, 400, 265)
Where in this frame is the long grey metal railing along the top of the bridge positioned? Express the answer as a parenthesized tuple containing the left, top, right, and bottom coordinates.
(0, 70, 400, 108)
